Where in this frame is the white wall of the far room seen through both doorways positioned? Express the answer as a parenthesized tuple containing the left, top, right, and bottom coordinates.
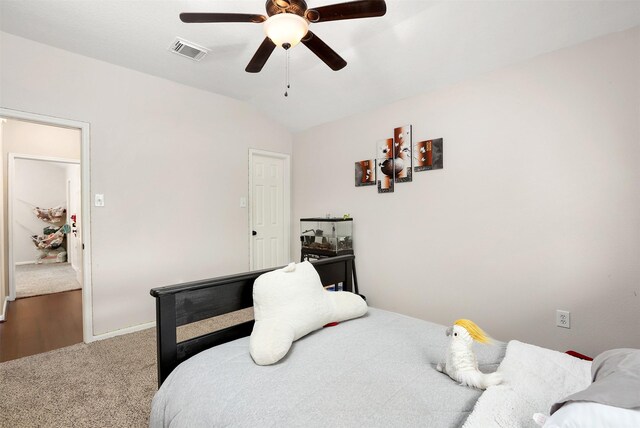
(12, 159, 67, 264)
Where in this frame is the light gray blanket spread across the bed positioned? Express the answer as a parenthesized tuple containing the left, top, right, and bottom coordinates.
(150, 309, 505, 427)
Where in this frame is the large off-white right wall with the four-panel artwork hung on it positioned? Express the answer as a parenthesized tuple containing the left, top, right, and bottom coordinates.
(293, 28, 640, 354)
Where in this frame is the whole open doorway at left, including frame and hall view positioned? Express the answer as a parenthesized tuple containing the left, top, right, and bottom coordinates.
(0, 109, 93, 361)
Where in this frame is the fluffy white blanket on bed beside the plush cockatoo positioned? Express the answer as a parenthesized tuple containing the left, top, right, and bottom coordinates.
(463, 340, 591, 428)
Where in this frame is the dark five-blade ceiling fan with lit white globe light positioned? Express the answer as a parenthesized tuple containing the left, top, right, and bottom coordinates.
(180, 0, 387, 73)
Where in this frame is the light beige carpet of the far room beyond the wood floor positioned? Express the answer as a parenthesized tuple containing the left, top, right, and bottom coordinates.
(16, 263, 82, 298)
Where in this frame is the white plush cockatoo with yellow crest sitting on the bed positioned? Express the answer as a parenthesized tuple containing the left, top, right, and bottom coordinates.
(436, 319, 502, 389)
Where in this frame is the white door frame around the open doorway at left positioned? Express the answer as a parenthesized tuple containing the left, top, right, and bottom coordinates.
(0, 107, 96, 343)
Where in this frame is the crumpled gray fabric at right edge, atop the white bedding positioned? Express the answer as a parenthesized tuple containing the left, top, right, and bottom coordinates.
(551, 349, 640, 415)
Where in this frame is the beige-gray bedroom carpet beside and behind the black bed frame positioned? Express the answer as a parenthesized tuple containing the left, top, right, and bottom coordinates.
(0, 308, 253, 428)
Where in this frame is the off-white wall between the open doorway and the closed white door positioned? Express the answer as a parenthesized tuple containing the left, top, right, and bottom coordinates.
(0, 33, 291, 334)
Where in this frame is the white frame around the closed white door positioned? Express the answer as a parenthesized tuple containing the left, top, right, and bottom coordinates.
(247, 149, 291, 270)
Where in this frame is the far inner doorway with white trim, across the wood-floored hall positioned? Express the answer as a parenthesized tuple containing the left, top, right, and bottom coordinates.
(7, 153, 82, 299)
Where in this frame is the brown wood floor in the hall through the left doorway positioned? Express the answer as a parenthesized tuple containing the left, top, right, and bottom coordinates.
(0, 290, 82, 362)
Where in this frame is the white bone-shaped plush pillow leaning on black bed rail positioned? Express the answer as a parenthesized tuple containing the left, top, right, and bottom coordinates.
(249, 262, 367, 366)
